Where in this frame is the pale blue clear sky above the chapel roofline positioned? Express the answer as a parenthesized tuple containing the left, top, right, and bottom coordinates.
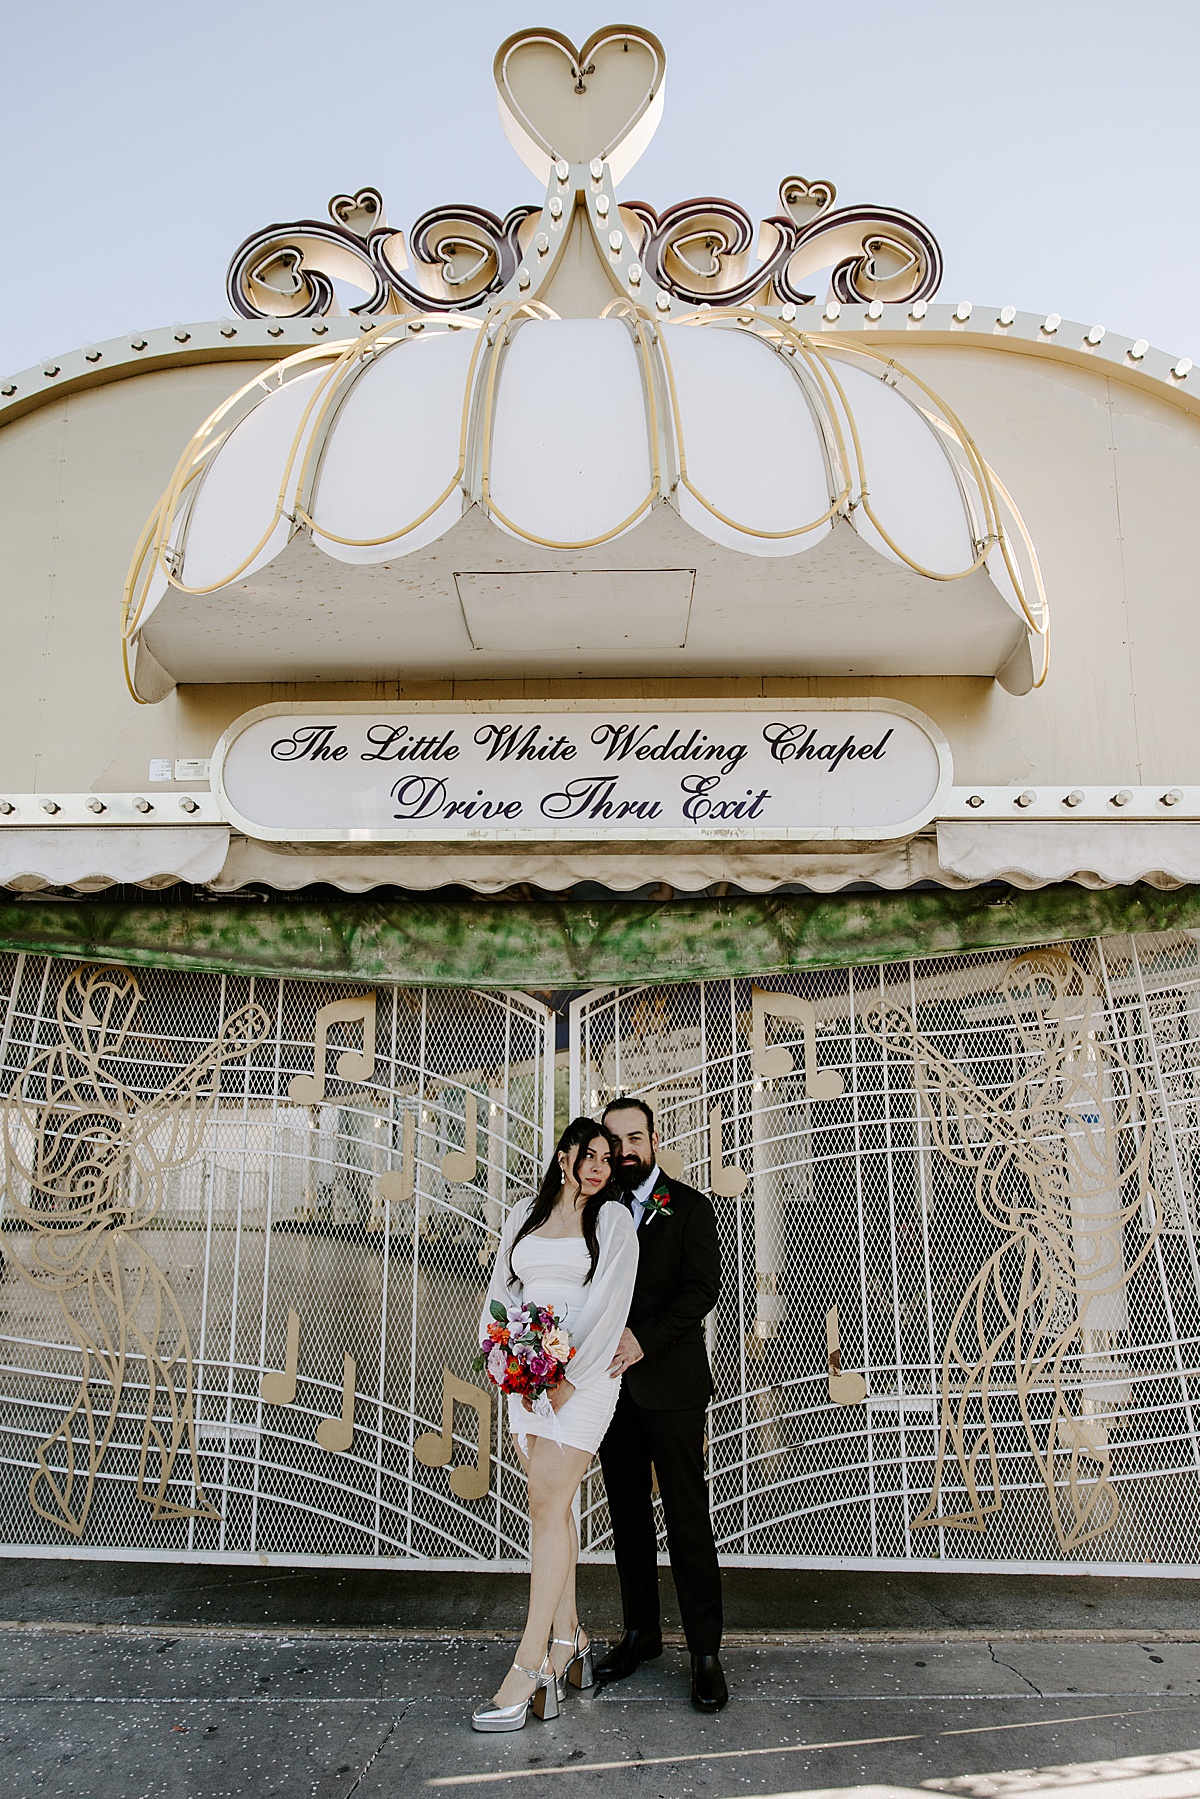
(0, 0, 1200, 374)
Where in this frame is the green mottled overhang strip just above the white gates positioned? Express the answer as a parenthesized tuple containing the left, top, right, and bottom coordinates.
(0, 883, 1200, 988)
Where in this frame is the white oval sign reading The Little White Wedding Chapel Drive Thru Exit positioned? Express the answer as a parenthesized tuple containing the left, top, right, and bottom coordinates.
(212, 700, 952, 842)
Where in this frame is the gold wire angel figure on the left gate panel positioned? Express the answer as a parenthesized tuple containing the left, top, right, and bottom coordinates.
(4, 966, 270, 1538)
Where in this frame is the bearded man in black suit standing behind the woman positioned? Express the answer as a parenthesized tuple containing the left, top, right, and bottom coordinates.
(596, 1097, 729, 1711)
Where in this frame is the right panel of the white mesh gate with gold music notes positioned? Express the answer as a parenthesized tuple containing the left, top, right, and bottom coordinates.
(572, 934, 1200, 1574)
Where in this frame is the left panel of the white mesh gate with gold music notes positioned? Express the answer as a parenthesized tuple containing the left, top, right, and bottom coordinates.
(0, 955, 552, 1565)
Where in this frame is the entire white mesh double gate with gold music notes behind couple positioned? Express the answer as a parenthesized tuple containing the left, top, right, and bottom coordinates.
(0, 934, 1200, 1572)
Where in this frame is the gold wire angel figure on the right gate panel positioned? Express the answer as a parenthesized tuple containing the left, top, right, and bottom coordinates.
(864, 950, 1162, 1551)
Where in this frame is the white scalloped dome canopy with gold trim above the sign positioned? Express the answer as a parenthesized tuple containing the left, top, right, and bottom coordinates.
(128, 302, 1042, 698)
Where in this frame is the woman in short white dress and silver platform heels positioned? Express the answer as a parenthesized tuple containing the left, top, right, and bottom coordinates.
(471, 1119, 637, 1731)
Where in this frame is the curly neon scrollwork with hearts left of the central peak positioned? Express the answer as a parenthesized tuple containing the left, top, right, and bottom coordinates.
(225, 187, 538, 318)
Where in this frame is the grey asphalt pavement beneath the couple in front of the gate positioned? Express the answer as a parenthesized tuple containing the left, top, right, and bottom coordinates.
(0, 1562, 1200, 1799)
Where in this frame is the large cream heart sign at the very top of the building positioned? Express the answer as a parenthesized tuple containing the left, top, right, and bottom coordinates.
(493, 25, 667, 182)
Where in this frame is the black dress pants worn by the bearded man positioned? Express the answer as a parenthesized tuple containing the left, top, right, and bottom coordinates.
(599, 1389, 721, 1655)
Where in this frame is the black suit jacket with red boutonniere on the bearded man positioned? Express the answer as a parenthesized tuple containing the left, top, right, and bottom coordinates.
(624, 1173, 721, 1412)
